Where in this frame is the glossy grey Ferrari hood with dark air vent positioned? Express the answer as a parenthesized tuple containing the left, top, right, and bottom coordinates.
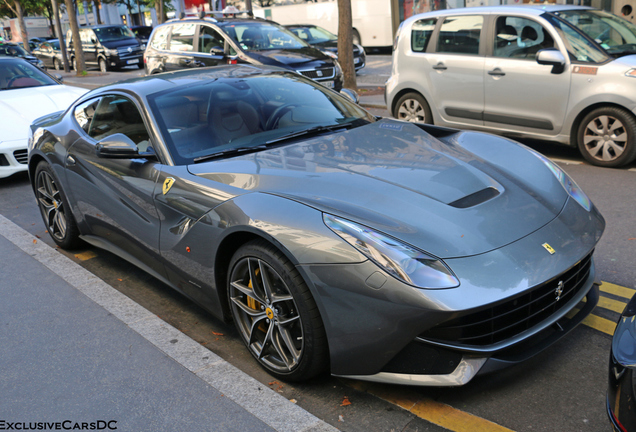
(189, 120, 568, 258)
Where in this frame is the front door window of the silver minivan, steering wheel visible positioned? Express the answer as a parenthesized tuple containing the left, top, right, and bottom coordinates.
(493, 17, 554, 60)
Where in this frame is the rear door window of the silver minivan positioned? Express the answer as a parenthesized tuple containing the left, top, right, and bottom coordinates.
(437, 15, 484, 54)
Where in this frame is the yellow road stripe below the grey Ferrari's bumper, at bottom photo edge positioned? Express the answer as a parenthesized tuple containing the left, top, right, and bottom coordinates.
(349, 381, 512, 432)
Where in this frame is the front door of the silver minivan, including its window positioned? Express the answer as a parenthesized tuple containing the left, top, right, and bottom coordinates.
(484, 15, 571, 135)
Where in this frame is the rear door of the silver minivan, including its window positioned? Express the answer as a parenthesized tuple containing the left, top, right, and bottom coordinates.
(422, 14, 485, 126)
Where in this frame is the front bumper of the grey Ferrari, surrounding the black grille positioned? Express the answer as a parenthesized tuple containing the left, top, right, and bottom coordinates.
(300, 199, 604, 385)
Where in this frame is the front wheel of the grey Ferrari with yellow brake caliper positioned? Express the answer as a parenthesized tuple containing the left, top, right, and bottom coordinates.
(227, 240, 328, 381)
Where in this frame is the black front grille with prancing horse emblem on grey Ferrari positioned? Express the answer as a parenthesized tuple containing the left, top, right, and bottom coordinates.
(420, 253, 592, 346)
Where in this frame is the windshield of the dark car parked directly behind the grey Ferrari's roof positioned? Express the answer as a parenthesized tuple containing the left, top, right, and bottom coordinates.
(223, 23, 308, 51)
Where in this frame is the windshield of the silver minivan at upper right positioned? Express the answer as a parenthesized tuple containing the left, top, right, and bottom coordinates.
(558, 10, 636, 56)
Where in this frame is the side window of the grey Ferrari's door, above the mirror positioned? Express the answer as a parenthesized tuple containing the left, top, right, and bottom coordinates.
(88, 95, 149, 152)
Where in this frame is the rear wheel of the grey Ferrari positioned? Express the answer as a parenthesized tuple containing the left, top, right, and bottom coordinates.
(34, 161, 81, 249)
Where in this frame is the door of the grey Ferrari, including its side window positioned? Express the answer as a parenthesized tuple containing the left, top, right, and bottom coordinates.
(66, 94, 165, 277)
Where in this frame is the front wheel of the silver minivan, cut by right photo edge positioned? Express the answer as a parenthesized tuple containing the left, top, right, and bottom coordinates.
(577, 107, 636, 167)
